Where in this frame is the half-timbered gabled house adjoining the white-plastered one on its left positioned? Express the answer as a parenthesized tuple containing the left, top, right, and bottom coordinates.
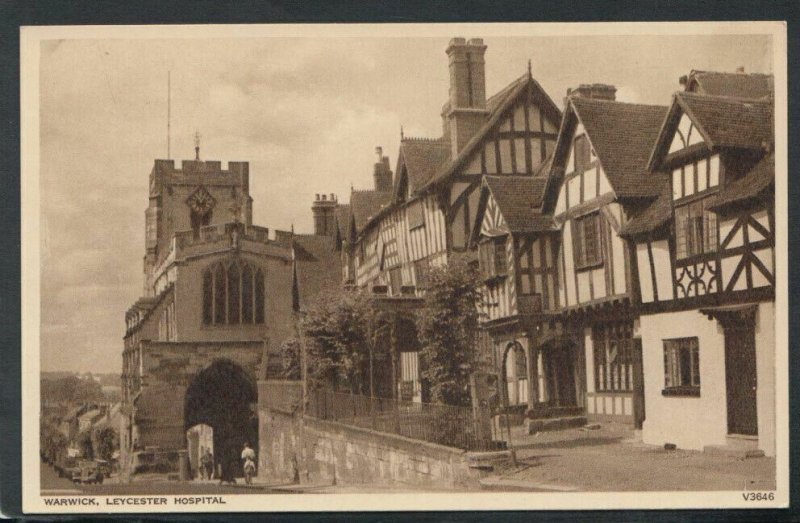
(543, 88, 667, 428)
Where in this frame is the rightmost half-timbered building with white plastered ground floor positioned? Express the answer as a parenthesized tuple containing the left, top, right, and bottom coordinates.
(623, 73, 775, 455)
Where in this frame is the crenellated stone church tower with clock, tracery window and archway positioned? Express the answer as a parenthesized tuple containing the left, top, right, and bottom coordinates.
(120, 154, 297, 474)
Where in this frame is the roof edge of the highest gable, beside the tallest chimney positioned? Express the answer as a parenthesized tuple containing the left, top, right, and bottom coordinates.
(418, 73, 561, 190)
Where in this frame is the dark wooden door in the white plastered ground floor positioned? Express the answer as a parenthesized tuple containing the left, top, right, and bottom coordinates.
(725, 323, 758, 436)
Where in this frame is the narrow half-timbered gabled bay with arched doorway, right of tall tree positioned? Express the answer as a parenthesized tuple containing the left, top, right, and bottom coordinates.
(473, 172, 583, 421)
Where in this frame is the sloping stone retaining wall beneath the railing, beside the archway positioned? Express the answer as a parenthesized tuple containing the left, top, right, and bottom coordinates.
(259, 382, 479, 488)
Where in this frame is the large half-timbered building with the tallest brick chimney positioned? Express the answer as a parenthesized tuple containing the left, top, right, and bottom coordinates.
(334, 38, 561, 404)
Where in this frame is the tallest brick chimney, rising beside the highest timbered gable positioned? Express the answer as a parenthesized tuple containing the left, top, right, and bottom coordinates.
(442, 38, 489, 158)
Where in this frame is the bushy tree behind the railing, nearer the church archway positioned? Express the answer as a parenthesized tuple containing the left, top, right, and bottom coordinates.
(300, 290, 376, 394)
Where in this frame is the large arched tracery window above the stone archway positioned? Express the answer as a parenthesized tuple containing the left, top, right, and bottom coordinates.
(203, 261, 264, 325)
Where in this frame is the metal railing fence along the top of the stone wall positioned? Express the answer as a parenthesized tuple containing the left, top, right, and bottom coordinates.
(306, 390, 496, 450)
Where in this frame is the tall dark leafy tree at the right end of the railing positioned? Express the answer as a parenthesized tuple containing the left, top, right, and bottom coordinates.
(416, 257, 481, 406)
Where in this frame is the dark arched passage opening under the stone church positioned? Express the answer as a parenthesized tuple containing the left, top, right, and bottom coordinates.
(183, 360, 258, 477)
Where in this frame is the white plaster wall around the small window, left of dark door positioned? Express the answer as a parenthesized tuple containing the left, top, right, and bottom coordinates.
(640, 310, 728, 450)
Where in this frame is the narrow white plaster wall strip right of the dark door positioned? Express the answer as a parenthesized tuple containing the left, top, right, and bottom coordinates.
(756, 302, 785, 456)
